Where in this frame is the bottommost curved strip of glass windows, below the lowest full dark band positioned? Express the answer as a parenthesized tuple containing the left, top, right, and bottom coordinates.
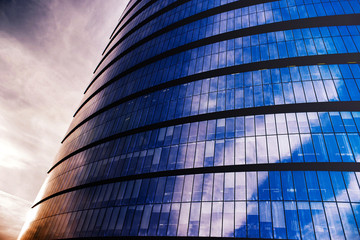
(23, 171, 360, 239)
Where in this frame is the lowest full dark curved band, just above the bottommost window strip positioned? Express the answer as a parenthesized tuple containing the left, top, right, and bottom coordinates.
(38, 162, 360, 207)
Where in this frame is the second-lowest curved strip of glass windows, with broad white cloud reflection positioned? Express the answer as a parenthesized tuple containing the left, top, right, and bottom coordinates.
(43, 112, 360, 198)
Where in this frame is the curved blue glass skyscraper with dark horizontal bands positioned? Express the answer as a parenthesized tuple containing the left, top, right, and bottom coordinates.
(20, 0, 360, 240)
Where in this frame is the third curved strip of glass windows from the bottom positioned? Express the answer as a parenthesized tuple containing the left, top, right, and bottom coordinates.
(56, 64, 359, 164)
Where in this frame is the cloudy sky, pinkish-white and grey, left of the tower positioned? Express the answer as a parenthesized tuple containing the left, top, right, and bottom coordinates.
(0, 0, 128, 240)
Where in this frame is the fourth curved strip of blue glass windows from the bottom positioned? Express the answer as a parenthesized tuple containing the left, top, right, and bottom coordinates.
(72, 23, 360, 137)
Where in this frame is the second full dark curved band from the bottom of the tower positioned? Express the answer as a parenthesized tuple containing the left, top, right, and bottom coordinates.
(48, 101, 360, 173)
